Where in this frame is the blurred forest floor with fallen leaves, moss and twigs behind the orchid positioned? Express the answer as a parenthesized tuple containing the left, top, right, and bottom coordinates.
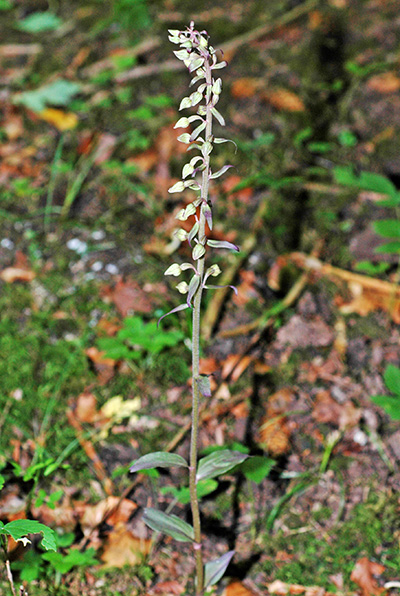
(0, 0, 400, 596)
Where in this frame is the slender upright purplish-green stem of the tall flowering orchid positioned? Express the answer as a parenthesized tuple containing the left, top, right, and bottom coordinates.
(189, 44, 212, 596)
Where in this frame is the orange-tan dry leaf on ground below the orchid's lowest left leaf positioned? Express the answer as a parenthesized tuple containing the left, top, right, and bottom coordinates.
(101, 524, 151, 568)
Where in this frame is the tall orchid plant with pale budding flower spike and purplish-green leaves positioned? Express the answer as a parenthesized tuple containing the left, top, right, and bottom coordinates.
(130, 22, 248, 596)
